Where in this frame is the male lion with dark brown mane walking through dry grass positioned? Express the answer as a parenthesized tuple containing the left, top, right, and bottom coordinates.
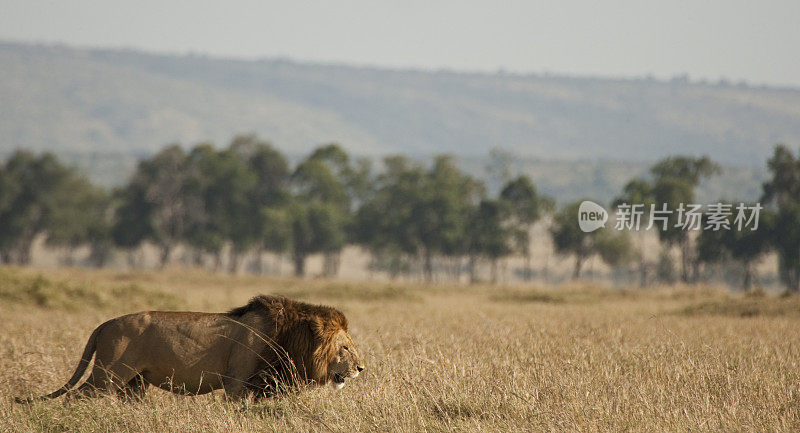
(17, 295, 364, 402)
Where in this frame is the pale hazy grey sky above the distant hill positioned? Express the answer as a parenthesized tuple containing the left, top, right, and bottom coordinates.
(0, 0, 800, 86)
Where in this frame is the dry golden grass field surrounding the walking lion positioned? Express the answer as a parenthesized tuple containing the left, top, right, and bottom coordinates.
(0, 268, 800, 433)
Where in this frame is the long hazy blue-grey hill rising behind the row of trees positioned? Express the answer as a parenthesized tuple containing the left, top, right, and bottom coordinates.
(0, 43, 800, 200)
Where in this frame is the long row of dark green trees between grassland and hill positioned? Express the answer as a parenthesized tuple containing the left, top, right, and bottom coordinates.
(0, 135, 800, 292)
